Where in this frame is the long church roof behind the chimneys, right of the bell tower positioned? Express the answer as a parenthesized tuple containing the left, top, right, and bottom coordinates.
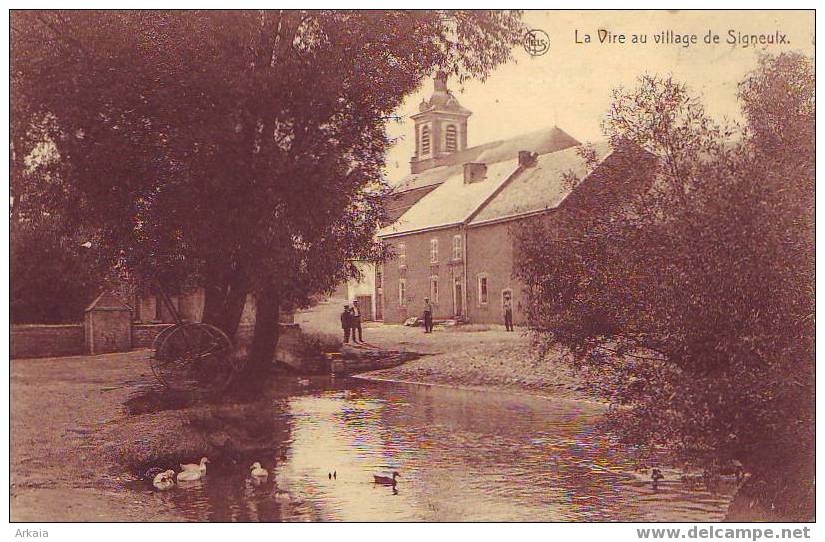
(394, 126, 581, 193)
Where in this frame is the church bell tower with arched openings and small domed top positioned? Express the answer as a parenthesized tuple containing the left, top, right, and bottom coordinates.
(410, 71, 472, 173)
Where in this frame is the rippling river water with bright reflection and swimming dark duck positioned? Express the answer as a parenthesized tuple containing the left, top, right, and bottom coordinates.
(148, 380, 732, 521)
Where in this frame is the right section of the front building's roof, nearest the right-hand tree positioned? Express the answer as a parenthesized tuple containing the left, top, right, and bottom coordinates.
(470, 142, 612, 225)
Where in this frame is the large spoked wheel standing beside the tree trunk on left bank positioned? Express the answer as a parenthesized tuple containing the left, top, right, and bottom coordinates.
(152, 323, 235, 391)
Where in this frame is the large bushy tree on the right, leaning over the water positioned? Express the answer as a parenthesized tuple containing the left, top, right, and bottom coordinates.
(518, 54, 814, 519)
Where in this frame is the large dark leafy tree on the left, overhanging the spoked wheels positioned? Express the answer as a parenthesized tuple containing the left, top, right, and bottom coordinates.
(12, 10, 522, 372)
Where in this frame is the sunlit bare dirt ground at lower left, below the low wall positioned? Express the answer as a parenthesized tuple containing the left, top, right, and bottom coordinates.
(10, 350, 181, 521)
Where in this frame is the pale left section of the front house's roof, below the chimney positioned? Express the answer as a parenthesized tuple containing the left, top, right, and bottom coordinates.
(378, 158, 518, 237)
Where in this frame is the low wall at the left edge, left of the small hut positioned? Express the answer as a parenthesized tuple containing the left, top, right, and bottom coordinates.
(10, 324, 86, 358)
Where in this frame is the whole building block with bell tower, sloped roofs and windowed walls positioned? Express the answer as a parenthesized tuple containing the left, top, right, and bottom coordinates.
(376, 74, 650, 324)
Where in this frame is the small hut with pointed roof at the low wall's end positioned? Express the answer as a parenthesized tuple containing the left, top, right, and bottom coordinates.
(84, 291, 132, 354)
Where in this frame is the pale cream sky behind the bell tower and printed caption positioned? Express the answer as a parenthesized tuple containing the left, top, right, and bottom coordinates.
(387, 10, 814, 183)
